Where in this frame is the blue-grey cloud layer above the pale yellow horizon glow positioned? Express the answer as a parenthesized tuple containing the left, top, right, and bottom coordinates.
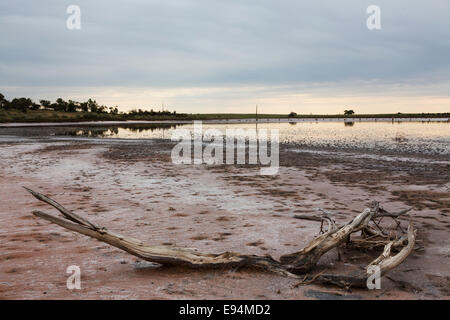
(0, 0, 450, 87)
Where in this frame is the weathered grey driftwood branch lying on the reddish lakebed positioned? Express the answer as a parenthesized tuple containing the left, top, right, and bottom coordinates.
(25, 188, 415, 287)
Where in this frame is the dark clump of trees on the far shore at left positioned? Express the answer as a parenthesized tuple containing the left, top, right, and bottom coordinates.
(0, 93, 181, 116)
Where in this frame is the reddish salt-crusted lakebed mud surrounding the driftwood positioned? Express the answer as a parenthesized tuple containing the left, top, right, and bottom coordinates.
(0, 138, 450, 299)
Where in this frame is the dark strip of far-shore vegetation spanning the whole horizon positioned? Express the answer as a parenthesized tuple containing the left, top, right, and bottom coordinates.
(0, 93, 450, 123)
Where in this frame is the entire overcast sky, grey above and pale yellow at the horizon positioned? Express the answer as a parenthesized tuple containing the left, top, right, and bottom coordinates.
(0, 0, 450, 113)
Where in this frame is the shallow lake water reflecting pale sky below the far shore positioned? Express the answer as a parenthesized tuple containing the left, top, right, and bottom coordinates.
(0, 120, 450, 155)
